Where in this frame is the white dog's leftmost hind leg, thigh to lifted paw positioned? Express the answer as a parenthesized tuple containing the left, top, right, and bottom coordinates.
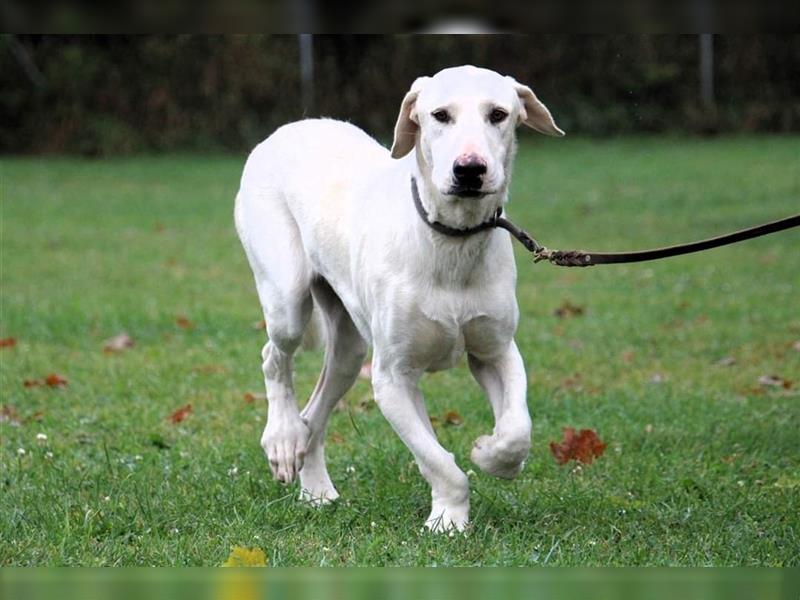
(235, 190, 313, 483)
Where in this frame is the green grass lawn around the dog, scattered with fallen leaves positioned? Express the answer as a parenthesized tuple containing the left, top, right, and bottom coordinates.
(0, 137, 800, 566)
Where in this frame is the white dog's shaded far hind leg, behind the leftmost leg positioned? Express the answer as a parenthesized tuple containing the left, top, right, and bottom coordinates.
(300, 278, 367, 504)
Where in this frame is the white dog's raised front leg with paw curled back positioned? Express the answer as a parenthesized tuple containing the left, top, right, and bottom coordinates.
(469, 340, 531, 479)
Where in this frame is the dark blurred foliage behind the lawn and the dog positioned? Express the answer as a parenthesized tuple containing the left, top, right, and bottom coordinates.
(0, 35, 800, 156)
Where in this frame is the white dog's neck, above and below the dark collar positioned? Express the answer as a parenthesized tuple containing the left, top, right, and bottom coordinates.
(408, 164, 506, 286)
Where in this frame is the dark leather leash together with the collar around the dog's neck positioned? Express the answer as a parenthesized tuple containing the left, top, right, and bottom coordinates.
(411, 176, 800, 267)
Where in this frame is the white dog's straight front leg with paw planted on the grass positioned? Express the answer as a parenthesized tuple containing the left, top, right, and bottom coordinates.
(372, 361, 469, 532)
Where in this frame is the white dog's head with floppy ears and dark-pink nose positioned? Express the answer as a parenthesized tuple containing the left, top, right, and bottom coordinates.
(392, 66, 564, 207)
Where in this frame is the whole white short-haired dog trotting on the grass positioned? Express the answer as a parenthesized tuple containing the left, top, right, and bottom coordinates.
(235, 66, 563, 531)
